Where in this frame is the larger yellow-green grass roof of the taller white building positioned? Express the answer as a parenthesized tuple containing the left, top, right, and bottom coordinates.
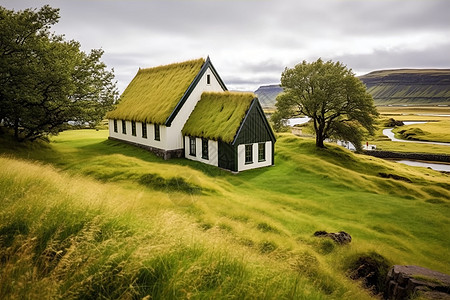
(107, 58, 205, 124)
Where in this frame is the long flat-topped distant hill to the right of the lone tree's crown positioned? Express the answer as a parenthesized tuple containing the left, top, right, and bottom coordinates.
(359, 69, 450, 105)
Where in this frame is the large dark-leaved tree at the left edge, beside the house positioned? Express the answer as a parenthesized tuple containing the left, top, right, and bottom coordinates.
(0, 6, 118, 140)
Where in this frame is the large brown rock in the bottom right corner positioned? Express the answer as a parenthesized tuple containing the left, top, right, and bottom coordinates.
(384, 265, 450, 300)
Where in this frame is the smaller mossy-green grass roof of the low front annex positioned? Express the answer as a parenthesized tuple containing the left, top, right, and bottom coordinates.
(182, 92, 256, 143)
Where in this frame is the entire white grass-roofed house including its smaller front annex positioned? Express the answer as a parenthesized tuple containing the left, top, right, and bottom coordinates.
(107, 57, 275, 172)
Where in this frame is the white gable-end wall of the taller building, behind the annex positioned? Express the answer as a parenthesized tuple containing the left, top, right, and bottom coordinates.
(165, 68, 223, 150)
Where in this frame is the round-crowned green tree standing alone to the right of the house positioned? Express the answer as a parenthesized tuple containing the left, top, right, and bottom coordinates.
(274, 59, 378, 150)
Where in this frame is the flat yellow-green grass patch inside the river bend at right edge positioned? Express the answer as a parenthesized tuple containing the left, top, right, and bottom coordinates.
(394, 119, 450, 143)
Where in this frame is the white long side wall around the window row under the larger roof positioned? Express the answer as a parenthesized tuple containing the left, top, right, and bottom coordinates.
(109, 120, 167, 149)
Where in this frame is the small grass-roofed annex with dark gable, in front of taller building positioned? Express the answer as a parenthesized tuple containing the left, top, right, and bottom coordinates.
(182, 92, 275, 172)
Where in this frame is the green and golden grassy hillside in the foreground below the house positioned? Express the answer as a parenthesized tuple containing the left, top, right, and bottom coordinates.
(0, 130, 450, 299)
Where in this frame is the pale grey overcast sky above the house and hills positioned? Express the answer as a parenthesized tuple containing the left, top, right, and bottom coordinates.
(0, 0, 450, 91)
